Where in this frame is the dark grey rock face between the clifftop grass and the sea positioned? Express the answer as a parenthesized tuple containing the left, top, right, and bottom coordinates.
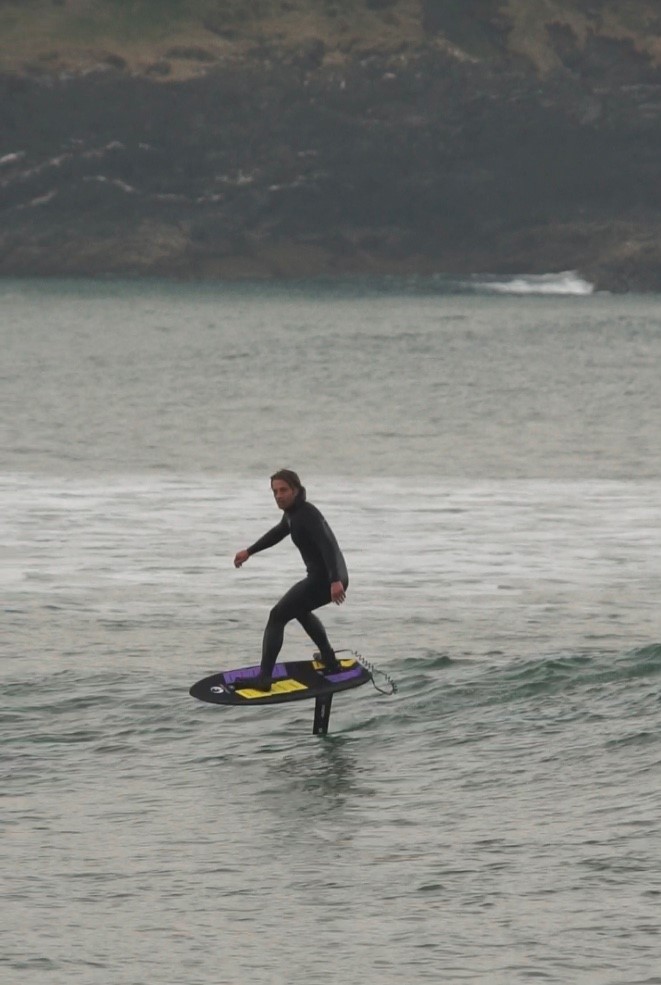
(0, 33, 661, 290)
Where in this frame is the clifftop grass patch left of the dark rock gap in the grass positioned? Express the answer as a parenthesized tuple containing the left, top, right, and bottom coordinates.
(0, 0, 422, 78)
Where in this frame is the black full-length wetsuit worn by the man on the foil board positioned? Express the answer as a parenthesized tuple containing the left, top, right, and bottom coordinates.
(248, 489, 349, 677)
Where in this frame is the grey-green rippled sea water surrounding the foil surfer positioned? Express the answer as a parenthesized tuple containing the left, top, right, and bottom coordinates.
(0, 274, 661, 985)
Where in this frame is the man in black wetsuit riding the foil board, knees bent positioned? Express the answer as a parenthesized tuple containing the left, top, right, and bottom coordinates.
(234, 469, 349, 691)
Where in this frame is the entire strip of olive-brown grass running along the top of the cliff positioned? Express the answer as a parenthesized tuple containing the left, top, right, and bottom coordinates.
(0, 0, 661, 78)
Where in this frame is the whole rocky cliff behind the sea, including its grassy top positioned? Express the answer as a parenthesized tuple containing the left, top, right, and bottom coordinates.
(0, 0, 661, 290)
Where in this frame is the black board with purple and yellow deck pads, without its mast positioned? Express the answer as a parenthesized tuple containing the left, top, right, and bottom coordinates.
(190, 657, 372, 707)
